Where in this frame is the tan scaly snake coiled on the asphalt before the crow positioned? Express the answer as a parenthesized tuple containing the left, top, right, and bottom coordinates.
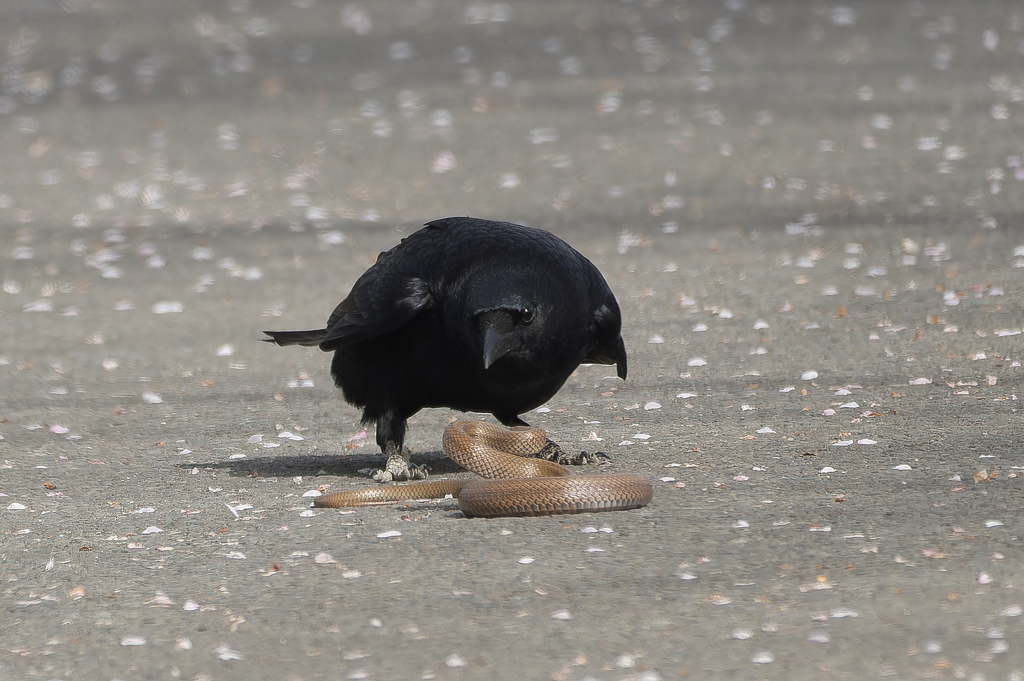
(314, 421, 653, 518)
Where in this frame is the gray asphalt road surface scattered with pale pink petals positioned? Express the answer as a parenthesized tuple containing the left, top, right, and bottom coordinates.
(0, 0, 1024, 681)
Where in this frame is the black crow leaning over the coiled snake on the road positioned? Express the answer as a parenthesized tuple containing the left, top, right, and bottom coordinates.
(263, 217, 626, 481)
